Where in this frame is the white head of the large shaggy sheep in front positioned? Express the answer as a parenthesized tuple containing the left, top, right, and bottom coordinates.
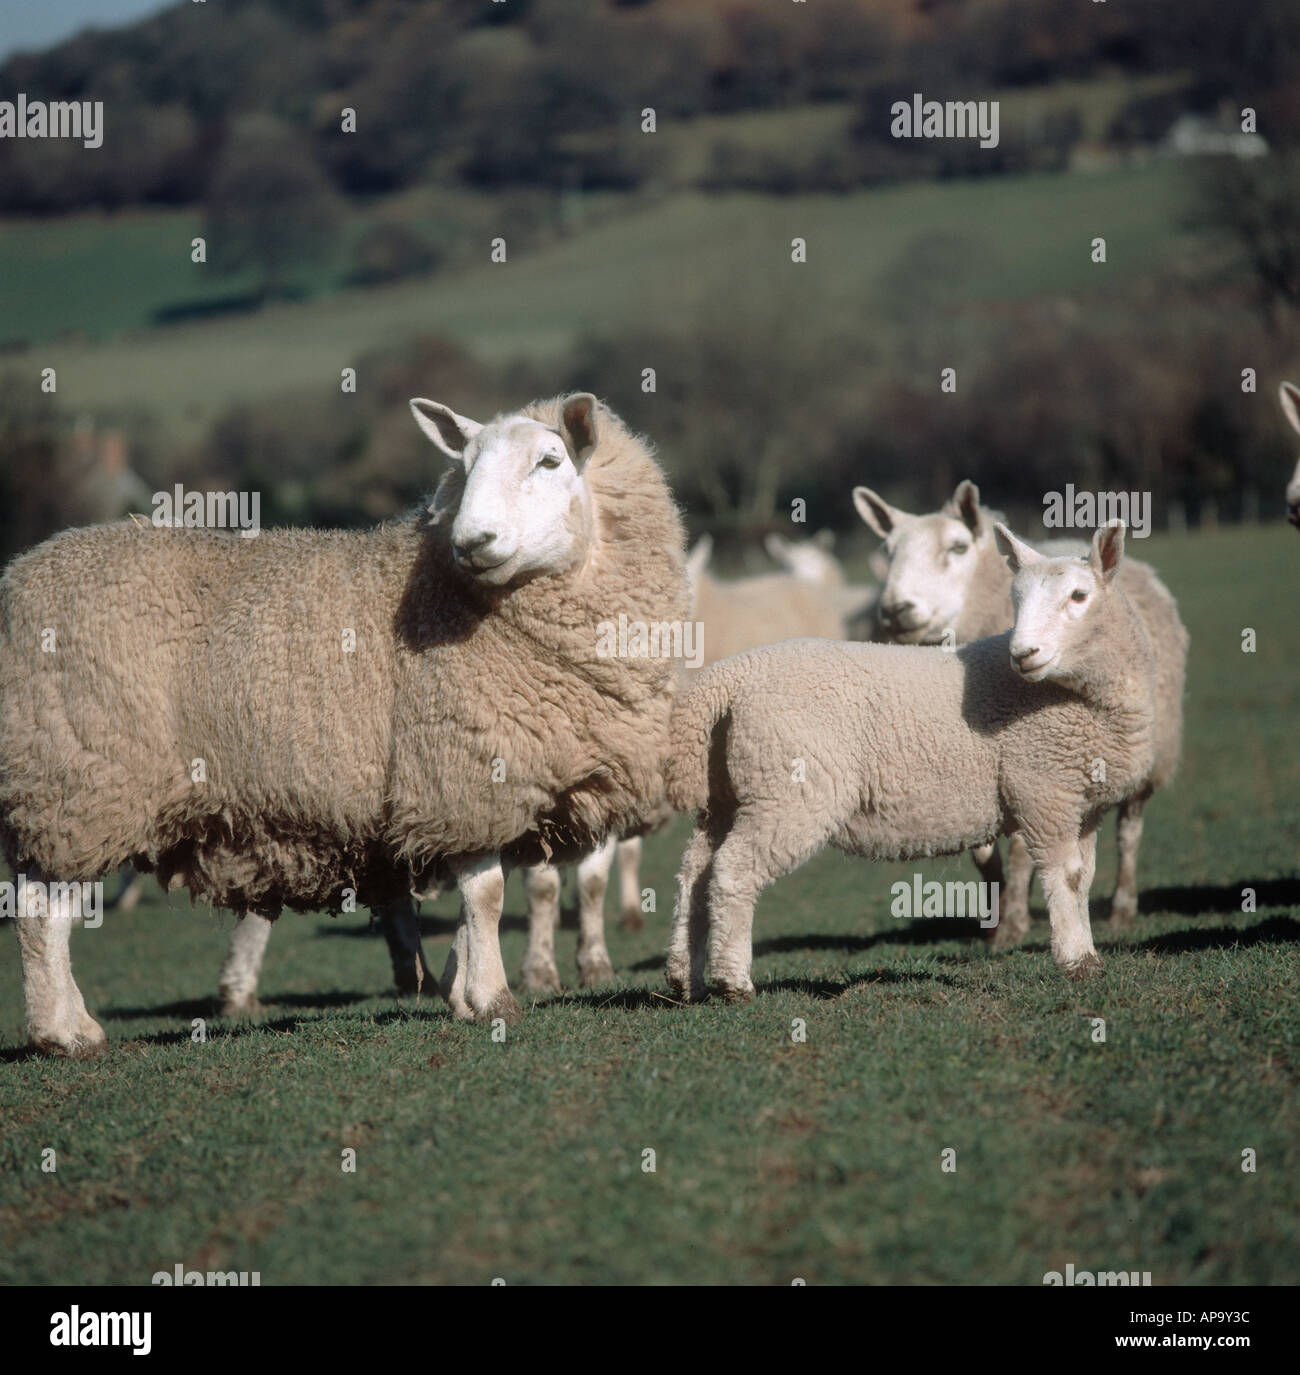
(411, 392, 597, 587)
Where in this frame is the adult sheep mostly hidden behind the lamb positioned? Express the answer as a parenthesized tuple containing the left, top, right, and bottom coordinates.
(853, 481, 1189, 945)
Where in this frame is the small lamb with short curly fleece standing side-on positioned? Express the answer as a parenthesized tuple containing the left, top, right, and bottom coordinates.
(666, 523, 1156, 1002)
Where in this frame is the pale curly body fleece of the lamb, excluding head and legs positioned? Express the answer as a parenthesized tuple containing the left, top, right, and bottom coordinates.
(667, 608, 1154, 852)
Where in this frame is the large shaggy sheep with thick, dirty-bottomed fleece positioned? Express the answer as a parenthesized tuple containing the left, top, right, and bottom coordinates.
(0, 393, 688, 1055)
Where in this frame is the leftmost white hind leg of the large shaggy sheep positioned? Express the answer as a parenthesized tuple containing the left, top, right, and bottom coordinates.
(14, 877, 107, 1056)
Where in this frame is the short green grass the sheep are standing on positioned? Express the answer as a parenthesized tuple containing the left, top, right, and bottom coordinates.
(0, 527, 1300, 1284)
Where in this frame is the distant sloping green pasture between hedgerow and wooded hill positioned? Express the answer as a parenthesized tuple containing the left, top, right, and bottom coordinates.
(0, 162, 1191, 437)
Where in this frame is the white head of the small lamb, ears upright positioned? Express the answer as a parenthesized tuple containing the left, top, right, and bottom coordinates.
(993, 521, 1124, 683)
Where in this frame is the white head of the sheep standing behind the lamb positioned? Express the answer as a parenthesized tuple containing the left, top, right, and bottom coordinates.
(853, 483, 993, 645)
